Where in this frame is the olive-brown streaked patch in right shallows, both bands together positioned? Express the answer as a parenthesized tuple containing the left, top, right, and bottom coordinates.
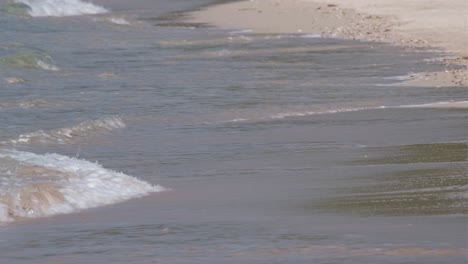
(305, 143, 468, 216)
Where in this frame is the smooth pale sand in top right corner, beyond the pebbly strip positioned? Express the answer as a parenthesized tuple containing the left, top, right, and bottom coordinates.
(305, 0, 468, 56)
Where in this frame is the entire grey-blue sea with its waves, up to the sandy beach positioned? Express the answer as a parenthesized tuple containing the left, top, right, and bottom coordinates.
(0, 0, 468, 264)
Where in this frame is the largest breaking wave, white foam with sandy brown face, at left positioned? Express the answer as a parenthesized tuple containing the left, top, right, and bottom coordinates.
(0, 150, 164, 222)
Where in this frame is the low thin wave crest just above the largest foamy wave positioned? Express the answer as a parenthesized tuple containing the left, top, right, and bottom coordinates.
(3, 116, 126, 145)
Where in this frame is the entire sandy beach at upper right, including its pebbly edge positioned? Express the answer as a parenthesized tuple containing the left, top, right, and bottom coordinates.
(191, 0, 468, 87)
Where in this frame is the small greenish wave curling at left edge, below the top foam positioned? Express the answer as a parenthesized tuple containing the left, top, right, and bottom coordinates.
(0, 51, 59, 71)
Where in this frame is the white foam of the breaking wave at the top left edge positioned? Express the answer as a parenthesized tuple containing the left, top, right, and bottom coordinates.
(15, 0, 108, 17)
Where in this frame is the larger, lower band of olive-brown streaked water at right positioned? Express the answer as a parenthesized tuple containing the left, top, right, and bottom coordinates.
(308, 167, 468, 216)
